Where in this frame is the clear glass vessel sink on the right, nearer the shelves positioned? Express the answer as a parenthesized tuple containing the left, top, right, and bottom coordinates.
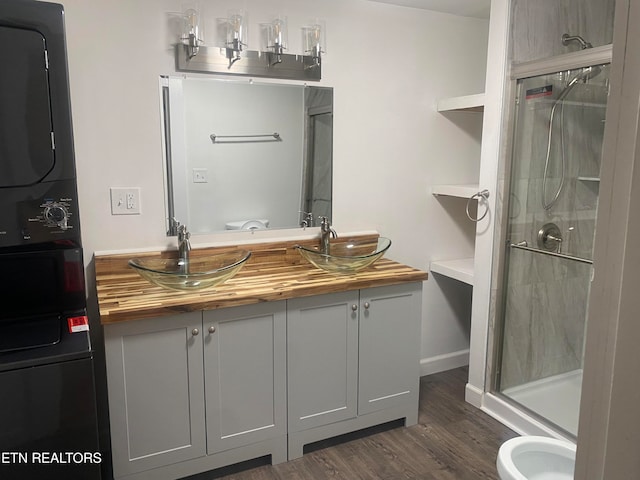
(296, 237, 391, 275)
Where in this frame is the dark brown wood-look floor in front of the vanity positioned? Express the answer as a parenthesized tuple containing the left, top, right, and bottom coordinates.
(189, 367, 516, 480)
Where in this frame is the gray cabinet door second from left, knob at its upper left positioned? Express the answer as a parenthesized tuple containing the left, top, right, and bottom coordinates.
(203, 301, 287, 454)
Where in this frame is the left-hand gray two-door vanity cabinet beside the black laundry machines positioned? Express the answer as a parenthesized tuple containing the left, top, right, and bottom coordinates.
(105, 301, 286, 479)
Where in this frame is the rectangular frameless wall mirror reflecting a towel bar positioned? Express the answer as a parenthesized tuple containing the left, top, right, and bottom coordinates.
(161, 76, 333, 235)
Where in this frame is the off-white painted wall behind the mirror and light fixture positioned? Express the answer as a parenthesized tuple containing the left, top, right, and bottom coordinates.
(64, 0, 488, 368)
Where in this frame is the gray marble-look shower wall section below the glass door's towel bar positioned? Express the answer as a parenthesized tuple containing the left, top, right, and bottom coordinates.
(500, 250, 591, 390)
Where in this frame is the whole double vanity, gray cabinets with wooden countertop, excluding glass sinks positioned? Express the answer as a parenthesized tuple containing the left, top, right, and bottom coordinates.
(95, 235, 427, 480)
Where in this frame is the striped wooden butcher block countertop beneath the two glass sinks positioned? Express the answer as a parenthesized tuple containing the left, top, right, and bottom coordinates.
(95, 237, 427, 325)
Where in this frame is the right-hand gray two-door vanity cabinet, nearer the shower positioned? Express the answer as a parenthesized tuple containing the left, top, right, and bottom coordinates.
(287, 283, 422, 460)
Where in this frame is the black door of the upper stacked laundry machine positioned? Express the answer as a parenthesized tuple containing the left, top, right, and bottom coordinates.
(0, 26, 55, 188)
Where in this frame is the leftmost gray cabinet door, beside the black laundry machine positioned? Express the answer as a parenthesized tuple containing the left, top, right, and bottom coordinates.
(104, 312, 205, 477)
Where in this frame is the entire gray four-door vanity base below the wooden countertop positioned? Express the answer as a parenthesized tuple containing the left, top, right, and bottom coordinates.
(104, 281, 422, 480)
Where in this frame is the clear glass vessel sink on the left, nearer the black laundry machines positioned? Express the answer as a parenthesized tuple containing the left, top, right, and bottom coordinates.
(129, 250, 251, 291)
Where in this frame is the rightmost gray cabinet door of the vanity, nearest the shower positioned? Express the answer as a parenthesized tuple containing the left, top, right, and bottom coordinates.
(358, 283, 422, 415)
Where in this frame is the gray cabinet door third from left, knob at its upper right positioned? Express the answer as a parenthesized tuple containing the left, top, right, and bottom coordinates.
(287, 291, 358, 432)
